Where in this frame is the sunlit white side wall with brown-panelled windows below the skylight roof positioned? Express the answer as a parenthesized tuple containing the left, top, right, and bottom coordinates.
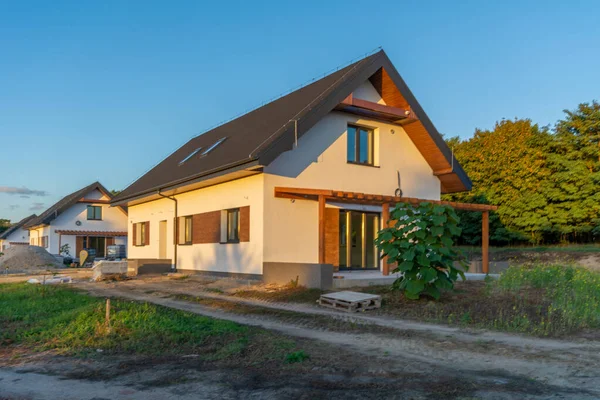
(128, 175, 263, 274)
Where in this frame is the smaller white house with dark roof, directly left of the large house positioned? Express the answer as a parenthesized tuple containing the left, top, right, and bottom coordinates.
(25, 182, 127, 258)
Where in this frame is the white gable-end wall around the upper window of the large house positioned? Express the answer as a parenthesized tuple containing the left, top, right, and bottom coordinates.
(264, 112, 440, 263)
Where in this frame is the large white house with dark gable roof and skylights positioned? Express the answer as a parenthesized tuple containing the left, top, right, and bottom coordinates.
(111, 51, 492, 286)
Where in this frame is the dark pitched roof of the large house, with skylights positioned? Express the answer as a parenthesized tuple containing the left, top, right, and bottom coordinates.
(113, 49, 471, 204)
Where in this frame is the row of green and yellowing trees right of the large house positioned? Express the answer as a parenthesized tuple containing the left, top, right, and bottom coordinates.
(445, 101, 600, 245)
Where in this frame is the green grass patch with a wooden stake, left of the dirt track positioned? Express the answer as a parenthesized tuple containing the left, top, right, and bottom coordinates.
(0, 283, 290, 362)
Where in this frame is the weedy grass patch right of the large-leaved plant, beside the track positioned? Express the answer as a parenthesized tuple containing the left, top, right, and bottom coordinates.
(357, 264, 600, 337)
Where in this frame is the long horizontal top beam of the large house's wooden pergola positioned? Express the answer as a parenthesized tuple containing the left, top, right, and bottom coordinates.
(274, 186, 498, 211)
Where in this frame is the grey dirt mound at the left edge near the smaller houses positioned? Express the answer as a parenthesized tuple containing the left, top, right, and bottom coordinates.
(0, 246, 62, 273)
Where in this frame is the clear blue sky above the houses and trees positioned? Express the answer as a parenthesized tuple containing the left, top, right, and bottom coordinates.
(0, 0, 600, 220)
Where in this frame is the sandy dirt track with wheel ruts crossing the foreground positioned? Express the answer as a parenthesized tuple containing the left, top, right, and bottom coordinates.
(0, 278, 600, 399)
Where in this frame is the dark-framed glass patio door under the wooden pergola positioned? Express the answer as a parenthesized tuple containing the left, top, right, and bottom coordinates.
(339, 210, 379, 270)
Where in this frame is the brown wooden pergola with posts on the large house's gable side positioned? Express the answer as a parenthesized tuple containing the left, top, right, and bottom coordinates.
(275, 187, 498, 275)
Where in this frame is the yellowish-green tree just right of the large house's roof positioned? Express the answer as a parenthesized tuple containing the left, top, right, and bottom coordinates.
(446, 119, 551, 243)
